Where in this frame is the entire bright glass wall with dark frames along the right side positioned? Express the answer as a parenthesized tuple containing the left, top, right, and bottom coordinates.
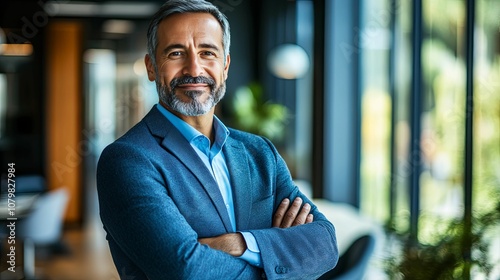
(359, 0, 500, 279)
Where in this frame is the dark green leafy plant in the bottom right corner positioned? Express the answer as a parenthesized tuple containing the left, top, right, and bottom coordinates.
(385, 192, 500, 280)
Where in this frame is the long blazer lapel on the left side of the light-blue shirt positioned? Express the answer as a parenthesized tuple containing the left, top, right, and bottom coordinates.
(146, 107, 232, 232)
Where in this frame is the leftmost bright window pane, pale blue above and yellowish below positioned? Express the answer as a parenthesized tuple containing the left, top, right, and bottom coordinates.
(359, 0, 393, 221)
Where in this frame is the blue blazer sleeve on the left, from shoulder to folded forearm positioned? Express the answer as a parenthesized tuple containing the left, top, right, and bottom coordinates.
(97, 142, 262, 279)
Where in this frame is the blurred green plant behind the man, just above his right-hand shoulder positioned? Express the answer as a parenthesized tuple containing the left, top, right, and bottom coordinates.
(231, 83, 289, 141)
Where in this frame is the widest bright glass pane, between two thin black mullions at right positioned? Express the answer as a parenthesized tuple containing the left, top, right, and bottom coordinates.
(418, 0, 466, 243)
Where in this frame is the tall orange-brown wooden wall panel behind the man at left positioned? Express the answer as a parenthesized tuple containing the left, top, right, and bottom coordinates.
(45, 21, 84, 222)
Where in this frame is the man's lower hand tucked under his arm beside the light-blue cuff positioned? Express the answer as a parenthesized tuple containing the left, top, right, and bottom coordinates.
(198, 232, 247, 257)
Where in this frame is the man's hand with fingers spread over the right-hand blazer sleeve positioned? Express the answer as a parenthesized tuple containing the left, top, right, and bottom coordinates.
(273, 197, 314, 228)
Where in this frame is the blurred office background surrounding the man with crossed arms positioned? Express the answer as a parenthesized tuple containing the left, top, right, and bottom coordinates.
(0, 0, 500, 280)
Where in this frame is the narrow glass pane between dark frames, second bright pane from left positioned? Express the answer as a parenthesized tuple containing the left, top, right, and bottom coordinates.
(388, 1, 412, 236)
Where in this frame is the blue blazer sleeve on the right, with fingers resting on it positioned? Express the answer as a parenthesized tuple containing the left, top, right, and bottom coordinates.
(250, 137, 339, 279)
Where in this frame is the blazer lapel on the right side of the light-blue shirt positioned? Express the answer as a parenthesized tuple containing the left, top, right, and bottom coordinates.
(224, 136, 253, 230)
